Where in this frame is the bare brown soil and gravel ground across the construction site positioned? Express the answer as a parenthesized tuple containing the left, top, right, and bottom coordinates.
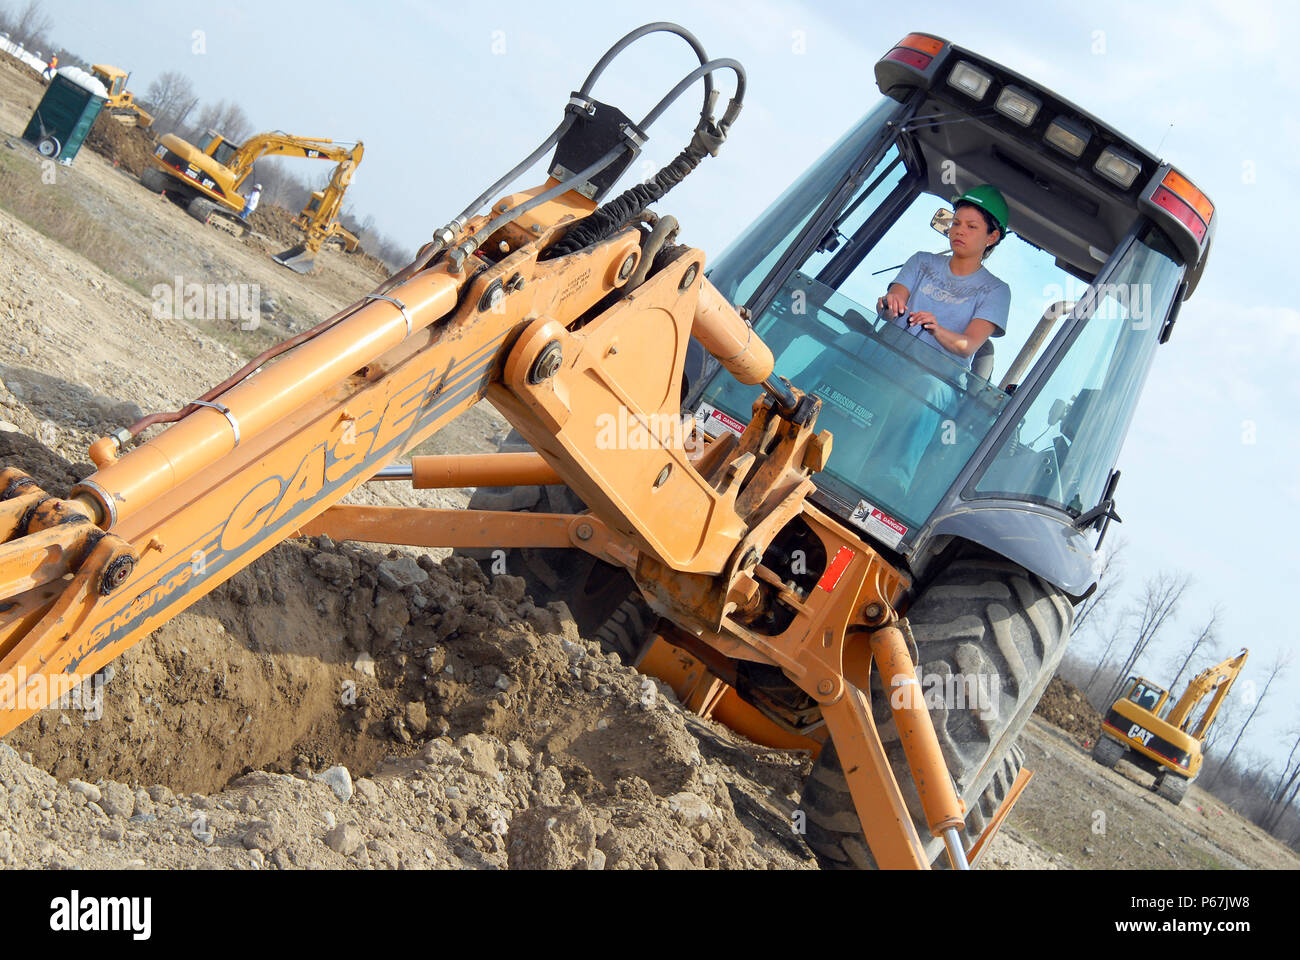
(0, 44, 1300, 869)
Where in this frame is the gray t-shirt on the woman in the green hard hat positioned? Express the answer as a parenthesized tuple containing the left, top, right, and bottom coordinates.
(893, 252, 1011, 368)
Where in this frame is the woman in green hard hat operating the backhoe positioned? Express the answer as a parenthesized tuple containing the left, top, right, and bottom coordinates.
(876, 183, 1011, 501)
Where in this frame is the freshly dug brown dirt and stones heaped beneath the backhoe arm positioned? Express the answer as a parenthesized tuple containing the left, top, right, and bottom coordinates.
(0, 442, 811, 868)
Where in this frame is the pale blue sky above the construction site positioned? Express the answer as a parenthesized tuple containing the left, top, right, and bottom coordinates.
(22, 0, 1300, 761)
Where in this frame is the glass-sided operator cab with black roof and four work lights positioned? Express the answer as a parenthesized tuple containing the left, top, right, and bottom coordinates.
(688, 34, 1214, 596)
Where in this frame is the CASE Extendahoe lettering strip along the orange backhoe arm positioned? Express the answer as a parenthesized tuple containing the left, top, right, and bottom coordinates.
(71, 332, 508, 673)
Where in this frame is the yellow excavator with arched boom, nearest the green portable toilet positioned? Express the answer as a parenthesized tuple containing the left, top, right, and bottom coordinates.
(140, 129, 364, 272)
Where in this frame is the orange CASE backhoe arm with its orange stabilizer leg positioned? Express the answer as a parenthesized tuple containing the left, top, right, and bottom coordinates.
(0, 174, 965, 866)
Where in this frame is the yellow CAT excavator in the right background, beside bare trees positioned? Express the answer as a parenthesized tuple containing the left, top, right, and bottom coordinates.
(1092, 649, 1249, 807)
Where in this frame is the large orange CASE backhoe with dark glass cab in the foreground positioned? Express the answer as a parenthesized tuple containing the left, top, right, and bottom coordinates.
(0, 23, 1216, 869)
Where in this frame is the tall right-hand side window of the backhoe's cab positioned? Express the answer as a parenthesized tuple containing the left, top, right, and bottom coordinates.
(974, 226, 1183, 516)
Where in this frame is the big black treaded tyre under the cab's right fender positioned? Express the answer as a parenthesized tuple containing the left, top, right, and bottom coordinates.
(801, 553, 1074, 869)
